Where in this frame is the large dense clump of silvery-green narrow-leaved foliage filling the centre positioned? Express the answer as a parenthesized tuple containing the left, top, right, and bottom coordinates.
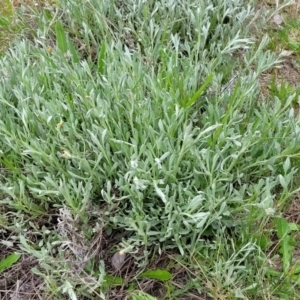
(0, 0, 299, 262)
